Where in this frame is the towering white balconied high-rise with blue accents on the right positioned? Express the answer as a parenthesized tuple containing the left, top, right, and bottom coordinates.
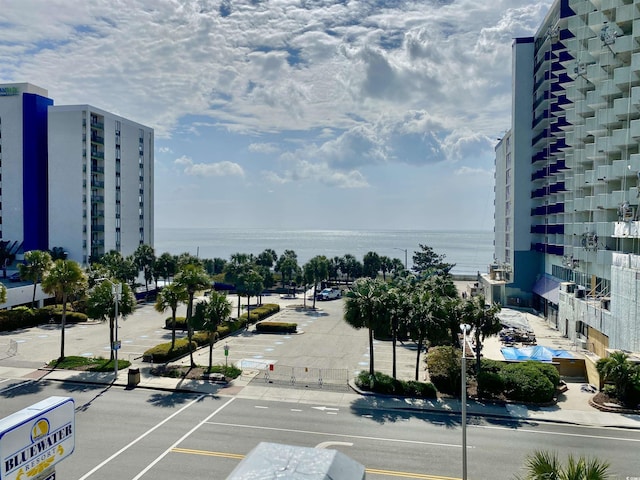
(483, 0, 640, 356)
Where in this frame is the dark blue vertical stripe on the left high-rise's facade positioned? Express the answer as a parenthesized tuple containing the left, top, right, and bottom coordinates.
(22, 93, 53, 252)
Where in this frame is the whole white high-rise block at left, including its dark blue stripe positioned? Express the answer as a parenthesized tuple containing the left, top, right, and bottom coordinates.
(0, 83, 154, 264)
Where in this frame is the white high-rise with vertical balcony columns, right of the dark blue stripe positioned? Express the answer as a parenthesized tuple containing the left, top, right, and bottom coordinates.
(49, 105, 153, 263)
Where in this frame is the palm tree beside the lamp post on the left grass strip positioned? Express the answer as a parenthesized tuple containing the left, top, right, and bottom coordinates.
(87, 280, 136, 360)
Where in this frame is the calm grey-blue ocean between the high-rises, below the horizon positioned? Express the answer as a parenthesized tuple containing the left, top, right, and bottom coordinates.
(154, 228, 493, 275)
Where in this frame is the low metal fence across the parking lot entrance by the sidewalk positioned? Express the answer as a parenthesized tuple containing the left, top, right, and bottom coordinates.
(256, 363, 349, 389)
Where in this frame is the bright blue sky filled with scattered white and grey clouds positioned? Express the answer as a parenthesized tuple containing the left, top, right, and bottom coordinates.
(0, 0, 552, 230)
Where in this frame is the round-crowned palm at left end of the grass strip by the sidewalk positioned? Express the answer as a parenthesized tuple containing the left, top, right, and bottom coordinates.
(42, 260, 86, 360)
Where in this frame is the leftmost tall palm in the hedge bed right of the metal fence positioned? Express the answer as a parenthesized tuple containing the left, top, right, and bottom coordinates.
(344, 278, 385, 378)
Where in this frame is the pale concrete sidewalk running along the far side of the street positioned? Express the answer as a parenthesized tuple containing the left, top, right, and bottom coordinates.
(0, 360, 640, 429)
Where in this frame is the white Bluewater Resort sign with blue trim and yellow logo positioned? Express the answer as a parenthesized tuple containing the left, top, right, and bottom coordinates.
(0, 397, 75, 480)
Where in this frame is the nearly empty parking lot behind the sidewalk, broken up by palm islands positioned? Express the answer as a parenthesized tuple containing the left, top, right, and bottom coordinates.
(0, 288, 428, 386)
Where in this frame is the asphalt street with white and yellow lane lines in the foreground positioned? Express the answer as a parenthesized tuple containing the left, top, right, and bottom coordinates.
(0, 381, 640, 480)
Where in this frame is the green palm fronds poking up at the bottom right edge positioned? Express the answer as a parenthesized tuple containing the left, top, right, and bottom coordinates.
(516, 451, 611, 480)
